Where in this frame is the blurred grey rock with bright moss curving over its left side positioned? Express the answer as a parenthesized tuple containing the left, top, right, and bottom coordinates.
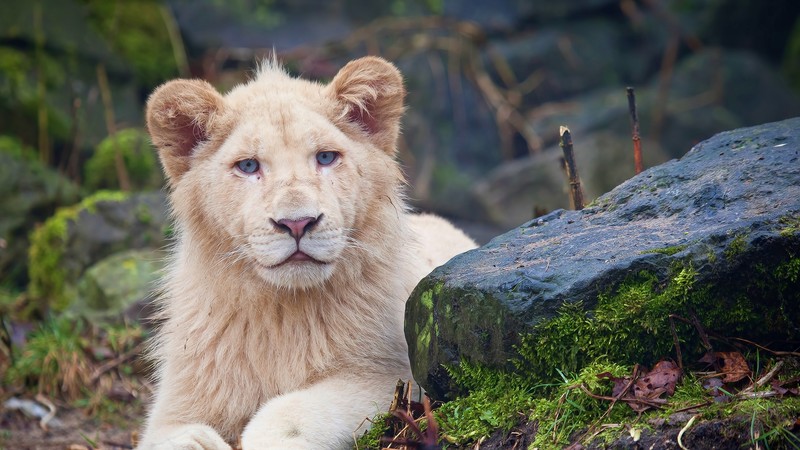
(28, 191, 169, 311)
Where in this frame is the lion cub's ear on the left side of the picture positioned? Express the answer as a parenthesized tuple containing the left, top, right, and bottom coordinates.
(147, 80, 225, 182)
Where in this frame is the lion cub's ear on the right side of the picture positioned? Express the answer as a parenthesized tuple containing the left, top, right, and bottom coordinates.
(328, 56, 406, 154)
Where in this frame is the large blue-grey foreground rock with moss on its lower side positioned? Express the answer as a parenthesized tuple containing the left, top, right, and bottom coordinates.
(406, 118, 800, 396)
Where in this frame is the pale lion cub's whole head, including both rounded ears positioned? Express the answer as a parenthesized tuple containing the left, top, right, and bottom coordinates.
(148, 58, 403, 289)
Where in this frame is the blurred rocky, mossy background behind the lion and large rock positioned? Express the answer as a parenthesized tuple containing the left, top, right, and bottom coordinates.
(0, 0, 800, 442)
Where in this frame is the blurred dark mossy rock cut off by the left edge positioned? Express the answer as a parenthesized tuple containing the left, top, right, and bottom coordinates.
(0, 136, 80, 289)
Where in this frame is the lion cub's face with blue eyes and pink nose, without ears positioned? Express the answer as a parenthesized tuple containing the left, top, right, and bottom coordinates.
(187, 105, 372, 287)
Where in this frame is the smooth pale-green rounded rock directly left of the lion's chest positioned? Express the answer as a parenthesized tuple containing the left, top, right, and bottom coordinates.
(72, 249, 165, 323)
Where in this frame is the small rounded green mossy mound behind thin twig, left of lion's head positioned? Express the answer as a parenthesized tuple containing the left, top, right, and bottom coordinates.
(85, 128, 163, 191)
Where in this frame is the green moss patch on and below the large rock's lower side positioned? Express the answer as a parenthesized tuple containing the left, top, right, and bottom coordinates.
(422, 251, 800, 449)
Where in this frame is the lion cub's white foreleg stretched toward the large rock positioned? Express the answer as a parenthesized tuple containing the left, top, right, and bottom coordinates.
(242, 375, 397, 450)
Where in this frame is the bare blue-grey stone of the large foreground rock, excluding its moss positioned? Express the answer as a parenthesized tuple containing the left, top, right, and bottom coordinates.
(406, 118, 800, 396)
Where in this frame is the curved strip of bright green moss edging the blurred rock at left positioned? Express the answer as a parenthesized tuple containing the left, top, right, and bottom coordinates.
(28, 191, 128, 313)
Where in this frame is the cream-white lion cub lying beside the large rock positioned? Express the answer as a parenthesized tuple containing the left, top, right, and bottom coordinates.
(140, 57, 475, 449)
